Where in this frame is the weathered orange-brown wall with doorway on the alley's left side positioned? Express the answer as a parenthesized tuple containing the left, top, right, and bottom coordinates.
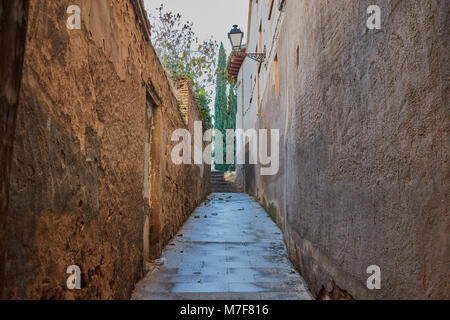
(4, 0, 207, 299)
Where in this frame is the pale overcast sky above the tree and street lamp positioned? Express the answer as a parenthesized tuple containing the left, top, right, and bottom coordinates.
(144, 0, 248, 54)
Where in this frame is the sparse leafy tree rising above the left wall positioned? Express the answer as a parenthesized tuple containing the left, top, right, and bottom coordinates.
(150, 4, 218, 128)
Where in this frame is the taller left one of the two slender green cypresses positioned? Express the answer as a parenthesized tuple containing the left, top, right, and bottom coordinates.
(214, 43, 228, 171)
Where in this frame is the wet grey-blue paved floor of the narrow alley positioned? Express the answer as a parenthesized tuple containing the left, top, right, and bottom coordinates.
(132, 193, 312, 300)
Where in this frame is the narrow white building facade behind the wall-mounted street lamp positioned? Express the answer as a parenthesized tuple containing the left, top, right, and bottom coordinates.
(235, 0, 286, 193)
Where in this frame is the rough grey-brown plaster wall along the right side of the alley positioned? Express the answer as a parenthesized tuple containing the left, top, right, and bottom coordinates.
(246, 0, 450, 299)
